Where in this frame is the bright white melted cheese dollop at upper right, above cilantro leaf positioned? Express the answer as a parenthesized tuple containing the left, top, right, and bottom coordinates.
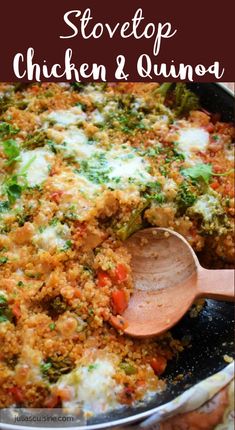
(178, 127, 209, 161)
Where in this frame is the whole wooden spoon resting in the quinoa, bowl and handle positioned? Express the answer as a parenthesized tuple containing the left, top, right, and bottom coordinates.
(122, 228, 234, 337)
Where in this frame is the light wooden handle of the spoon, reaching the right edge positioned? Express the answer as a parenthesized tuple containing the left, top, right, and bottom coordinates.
(197, 268, 234, 301)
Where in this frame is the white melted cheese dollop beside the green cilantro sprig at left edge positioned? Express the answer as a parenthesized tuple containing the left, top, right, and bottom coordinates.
(18, 148, 53, 187)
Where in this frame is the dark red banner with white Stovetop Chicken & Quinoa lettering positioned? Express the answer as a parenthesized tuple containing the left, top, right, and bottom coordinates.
(0, 0, 235, 82)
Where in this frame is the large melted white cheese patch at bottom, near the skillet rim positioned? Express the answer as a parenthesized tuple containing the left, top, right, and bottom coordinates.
(58, 359, 120, 415)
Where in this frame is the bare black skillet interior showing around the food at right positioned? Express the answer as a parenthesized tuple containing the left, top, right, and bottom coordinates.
(87, 83, 234, 426)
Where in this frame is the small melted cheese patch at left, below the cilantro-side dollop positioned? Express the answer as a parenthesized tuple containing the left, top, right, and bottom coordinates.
(33, 223, 70, 251)
